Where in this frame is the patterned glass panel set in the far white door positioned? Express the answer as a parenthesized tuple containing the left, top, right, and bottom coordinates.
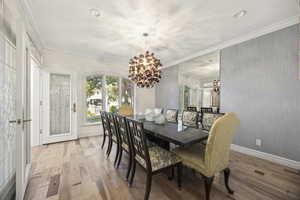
(50, 74, 71, 136)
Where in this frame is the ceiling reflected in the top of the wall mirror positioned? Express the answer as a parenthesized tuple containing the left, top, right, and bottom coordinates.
(179, 51, 220, 82)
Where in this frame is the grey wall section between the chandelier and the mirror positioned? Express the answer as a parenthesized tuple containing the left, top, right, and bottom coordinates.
(155, 66, 179, 109)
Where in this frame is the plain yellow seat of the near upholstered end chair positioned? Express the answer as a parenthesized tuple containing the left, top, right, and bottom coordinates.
(173, 143, 211, 176)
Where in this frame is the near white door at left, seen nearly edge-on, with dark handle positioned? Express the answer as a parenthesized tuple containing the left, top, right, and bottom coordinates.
(16, 22, 31, 200)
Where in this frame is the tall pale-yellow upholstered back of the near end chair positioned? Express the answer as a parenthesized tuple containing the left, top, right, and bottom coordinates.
(205, 113, 240, 175)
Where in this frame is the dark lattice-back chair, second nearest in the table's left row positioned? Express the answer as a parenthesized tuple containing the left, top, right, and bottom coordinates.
(115, 115, 132, 180)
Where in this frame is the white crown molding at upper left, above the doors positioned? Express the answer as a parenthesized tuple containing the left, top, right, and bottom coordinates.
(17, 0, 45, 52)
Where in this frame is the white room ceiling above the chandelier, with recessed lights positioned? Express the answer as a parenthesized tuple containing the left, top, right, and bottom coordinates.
(25, 0, 298, 69)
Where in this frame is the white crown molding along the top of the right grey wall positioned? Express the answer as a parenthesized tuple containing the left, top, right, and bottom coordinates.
(162, 15, 299, 69)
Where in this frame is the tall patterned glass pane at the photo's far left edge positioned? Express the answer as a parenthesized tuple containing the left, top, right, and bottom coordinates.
(0, 33, 17, 199)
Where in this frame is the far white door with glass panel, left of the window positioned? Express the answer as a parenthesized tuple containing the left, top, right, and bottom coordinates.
(42, 71, 77, 144)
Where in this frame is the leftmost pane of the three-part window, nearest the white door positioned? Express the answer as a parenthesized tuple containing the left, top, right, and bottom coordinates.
(85, 76, 103, 123)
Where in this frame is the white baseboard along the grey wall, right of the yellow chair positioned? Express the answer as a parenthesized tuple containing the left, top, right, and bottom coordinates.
(231, 144, 300, 170)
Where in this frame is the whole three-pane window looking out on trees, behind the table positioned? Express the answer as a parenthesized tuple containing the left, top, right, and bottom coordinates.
(85, 75, 134, 124)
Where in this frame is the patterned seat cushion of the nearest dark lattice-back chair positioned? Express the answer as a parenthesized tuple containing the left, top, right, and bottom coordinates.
(136, 146, 181, 172)
